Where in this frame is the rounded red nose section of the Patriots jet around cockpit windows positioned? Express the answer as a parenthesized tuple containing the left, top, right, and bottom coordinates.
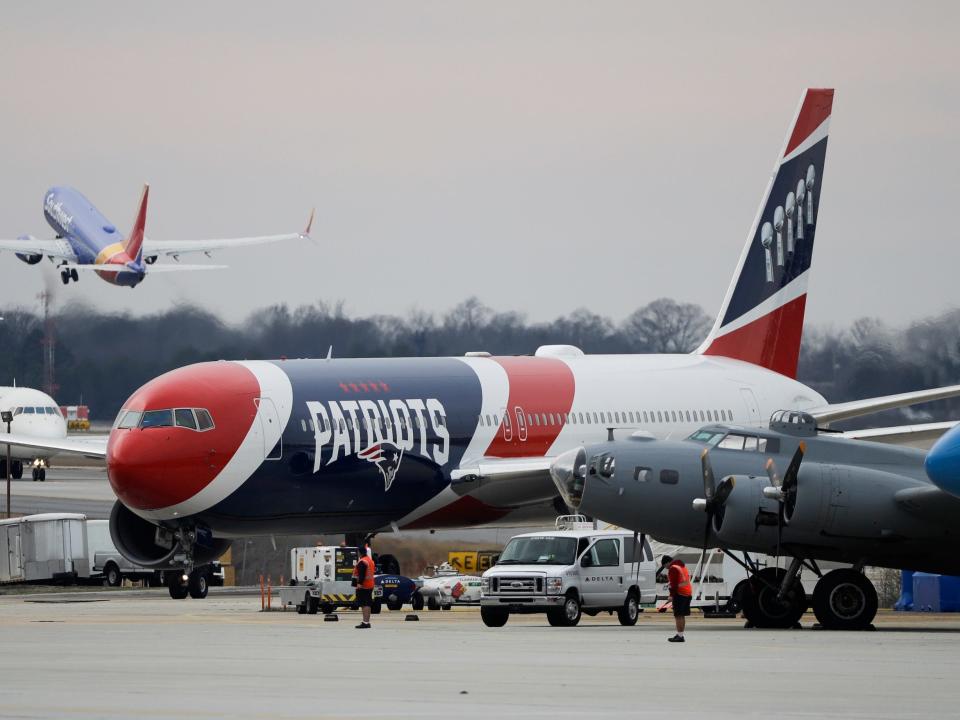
(107, 362, 260, 510)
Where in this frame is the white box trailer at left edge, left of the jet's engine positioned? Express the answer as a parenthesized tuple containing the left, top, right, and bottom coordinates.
(0, 513, 90, 583)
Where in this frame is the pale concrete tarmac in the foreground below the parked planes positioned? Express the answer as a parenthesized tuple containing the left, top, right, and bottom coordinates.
(0, 588, 960, 718)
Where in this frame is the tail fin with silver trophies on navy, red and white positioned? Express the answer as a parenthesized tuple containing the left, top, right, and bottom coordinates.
(697, 89, 833, 377)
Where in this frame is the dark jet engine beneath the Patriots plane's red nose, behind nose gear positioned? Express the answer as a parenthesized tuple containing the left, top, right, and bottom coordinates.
(110, 501, 230, 568)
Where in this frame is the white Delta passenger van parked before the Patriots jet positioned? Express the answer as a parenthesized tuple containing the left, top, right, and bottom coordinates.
(480, 516, 657, 627)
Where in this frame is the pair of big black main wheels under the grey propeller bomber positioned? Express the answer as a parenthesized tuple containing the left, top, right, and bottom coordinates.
(725, 551, 878, 630)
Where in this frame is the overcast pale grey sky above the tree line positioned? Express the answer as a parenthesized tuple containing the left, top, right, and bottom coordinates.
(0, 0, 960, 325)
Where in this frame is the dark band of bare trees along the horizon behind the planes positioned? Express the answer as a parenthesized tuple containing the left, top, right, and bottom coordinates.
(0, 298, 960, 425)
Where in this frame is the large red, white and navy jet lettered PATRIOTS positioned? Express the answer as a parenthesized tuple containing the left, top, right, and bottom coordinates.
(8, 89, 960, 597)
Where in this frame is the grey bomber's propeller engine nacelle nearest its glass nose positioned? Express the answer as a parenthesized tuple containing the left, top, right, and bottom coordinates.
(713, 475, 779, 548)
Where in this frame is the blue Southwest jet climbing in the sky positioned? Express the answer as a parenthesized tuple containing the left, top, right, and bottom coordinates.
(0, 185, 313, 287)
